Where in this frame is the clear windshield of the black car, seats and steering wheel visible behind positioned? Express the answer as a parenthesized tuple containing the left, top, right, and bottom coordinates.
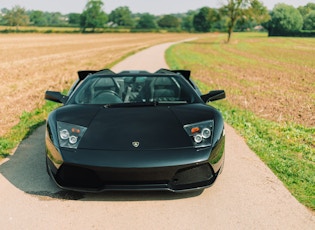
(69, 75, 200, 105)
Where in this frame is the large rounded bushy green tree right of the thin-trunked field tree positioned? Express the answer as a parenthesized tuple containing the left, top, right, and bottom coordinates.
(266, 3, 303, 36)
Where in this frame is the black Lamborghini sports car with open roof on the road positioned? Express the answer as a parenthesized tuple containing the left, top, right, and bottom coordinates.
(45, 69, 225, 192)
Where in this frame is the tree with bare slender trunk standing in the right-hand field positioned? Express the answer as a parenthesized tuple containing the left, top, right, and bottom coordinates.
(220, 0, 268, 42)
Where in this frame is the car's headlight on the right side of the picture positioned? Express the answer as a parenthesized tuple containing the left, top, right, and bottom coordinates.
(184, 120, 214, 147)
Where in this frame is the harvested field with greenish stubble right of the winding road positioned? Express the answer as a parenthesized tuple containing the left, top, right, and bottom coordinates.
(168, 33, 315, 127)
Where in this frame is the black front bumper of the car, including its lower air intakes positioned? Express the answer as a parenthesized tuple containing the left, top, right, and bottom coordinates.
(46, 139, 224, 192)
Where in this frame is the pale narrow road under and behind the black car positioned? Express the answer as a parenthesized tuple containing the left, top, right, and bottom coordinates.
(0, 40, 315, 230)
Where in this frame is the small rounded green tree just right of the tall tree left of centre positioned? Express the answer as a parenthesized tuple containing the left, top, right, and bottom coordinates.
(109, 6, 134, 27)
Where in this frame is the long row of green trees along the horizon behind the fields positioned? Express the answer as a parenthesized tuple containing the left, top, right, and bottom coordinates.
(0, 0, 315, 40)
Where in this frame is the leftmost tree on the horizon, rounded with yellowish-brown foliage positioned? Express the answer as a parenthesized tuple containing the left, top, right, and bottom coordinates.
(3, 6, 29, 30)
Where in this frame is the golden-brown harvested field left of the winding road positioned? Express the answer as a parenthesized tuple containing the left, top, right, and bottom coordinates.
(0, 33, 196, 136)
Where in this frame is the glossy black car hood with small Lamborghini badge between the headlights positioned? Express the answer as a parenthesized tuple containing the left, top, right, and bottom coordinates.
(57, 104, 215, 151)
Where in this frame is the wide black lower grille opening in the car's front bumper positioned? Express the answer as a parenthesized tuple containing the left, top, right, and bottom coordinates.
(55, 164, 215, 190)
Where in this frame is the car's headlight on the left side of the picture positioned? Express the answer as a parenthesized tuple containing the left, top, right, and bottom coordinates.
(57, 121, 87, 149)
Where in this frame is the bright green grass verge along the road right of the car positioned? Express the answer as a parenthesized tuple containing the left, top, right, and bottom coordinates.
(215, 101, 315, 210)
